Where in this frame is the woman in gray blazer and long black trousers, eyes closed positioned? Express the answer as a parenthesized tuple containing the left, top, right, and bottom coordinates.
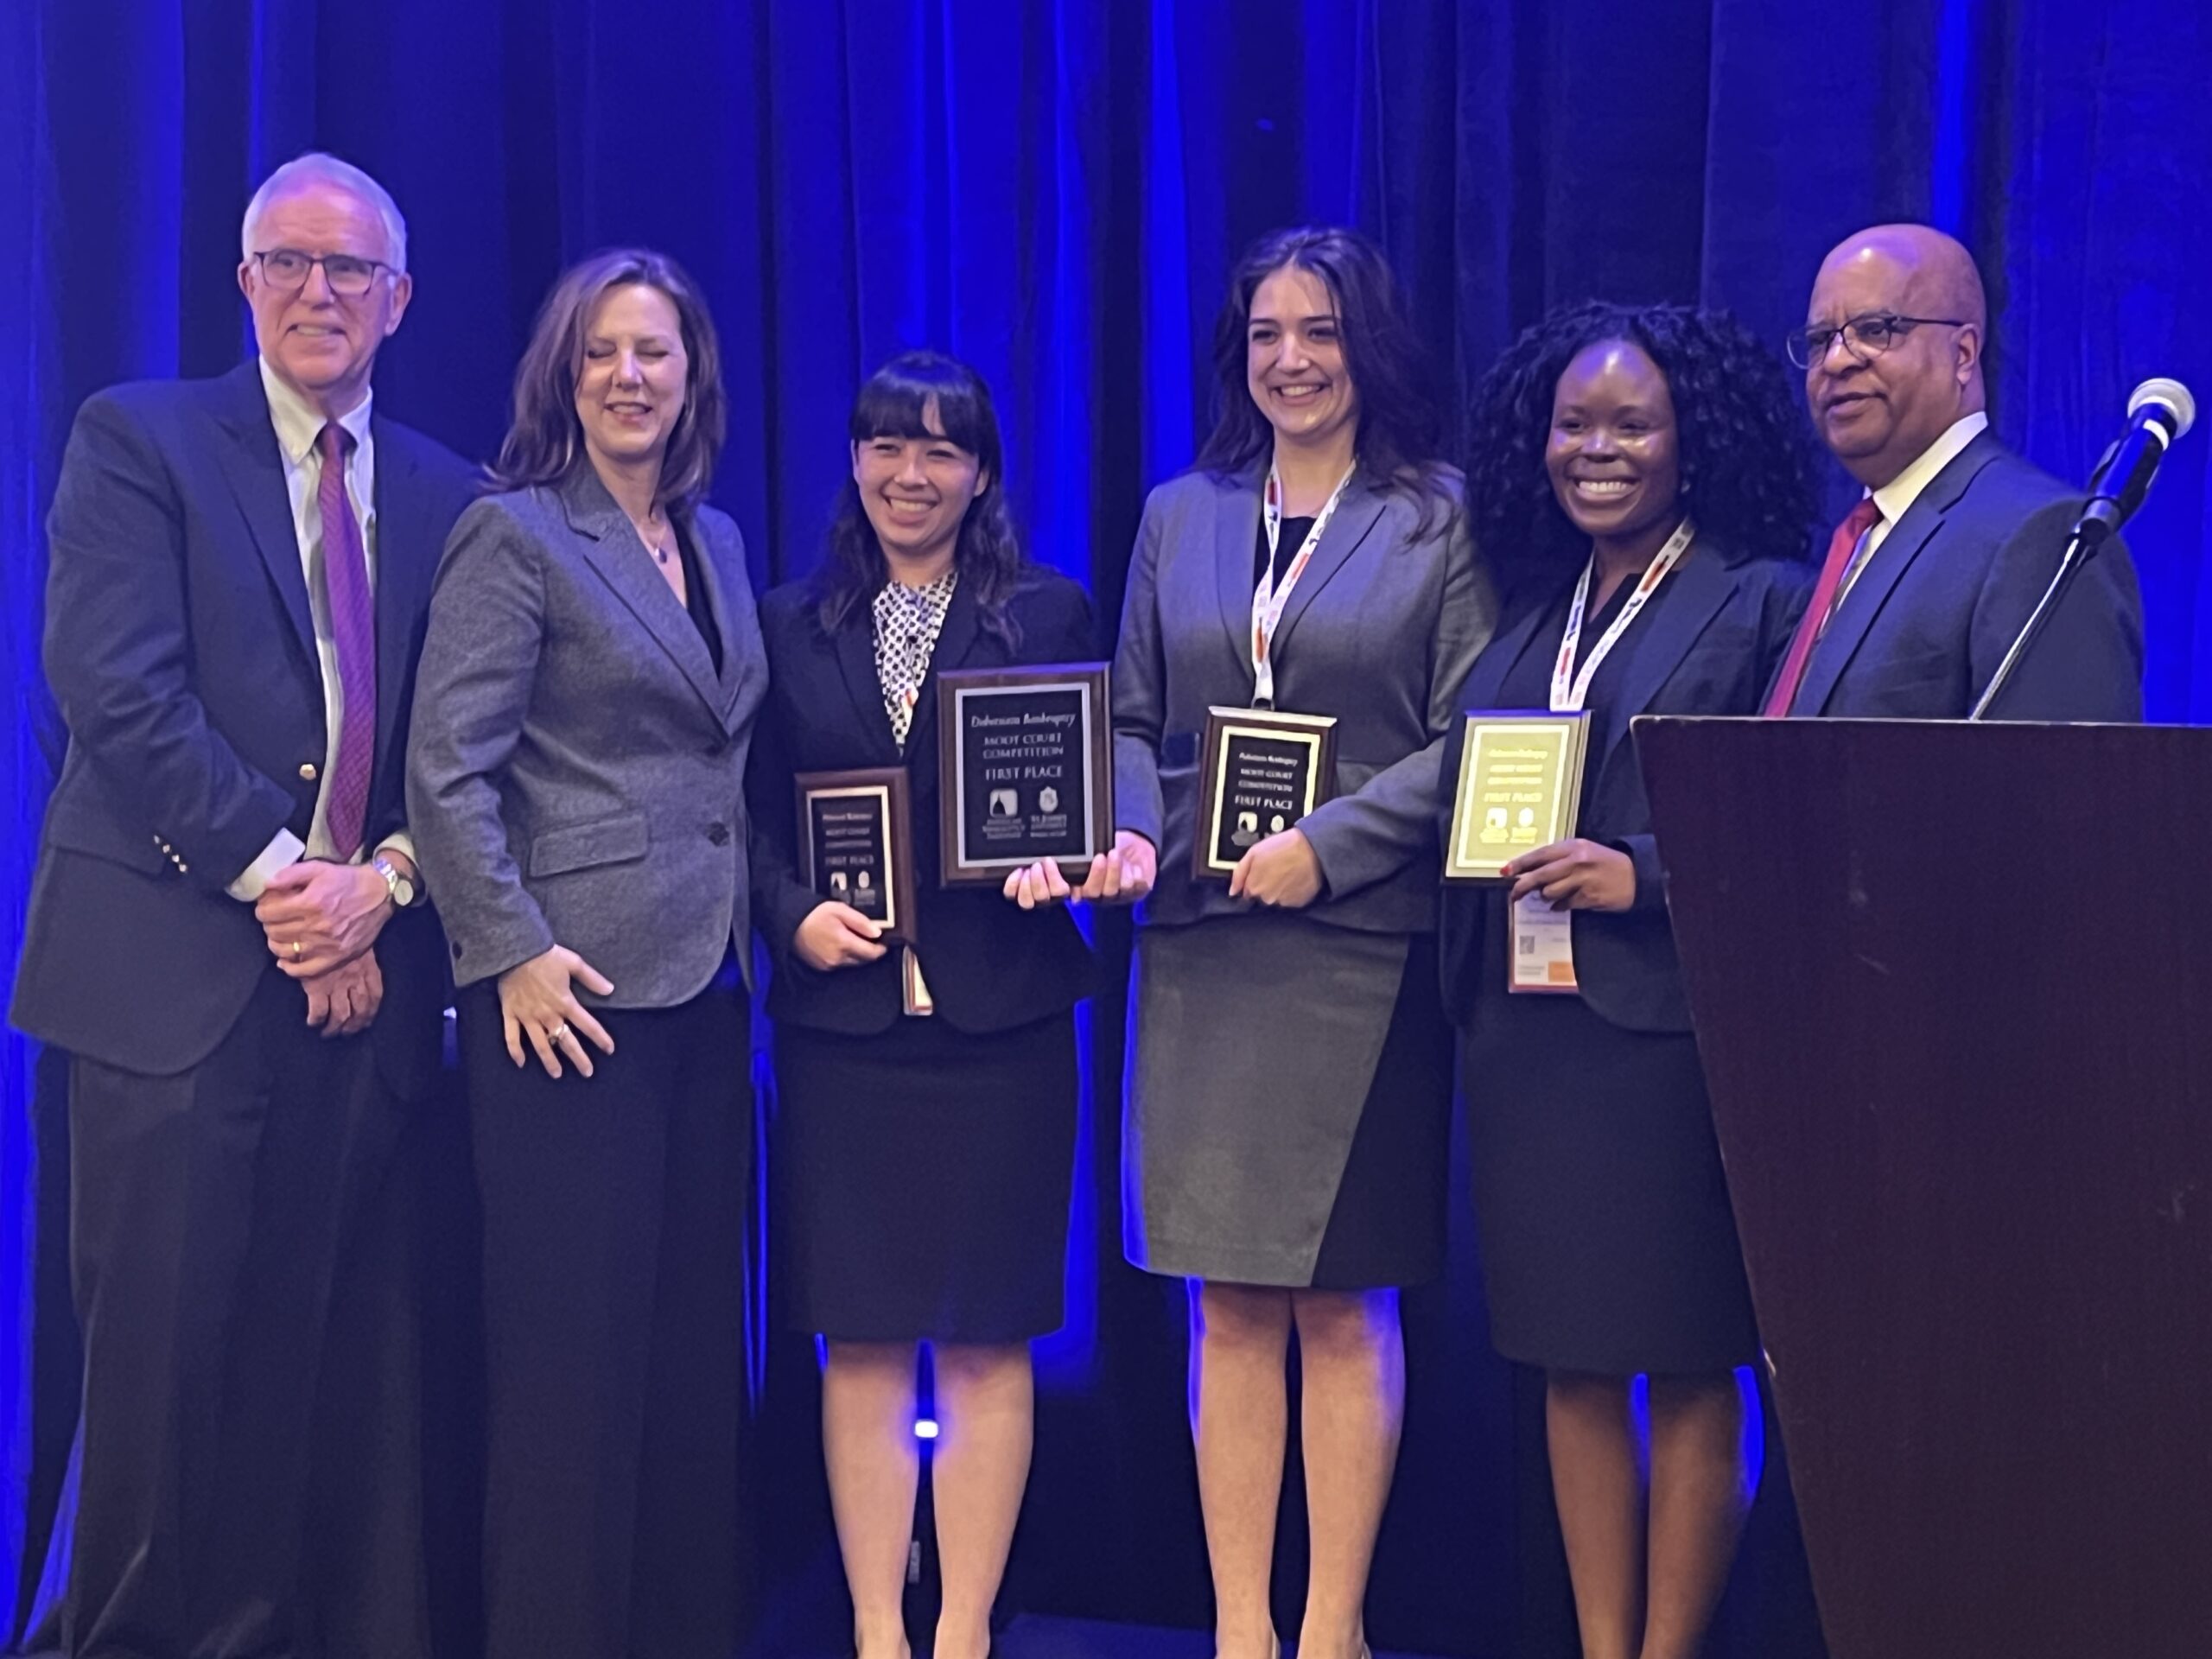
(407, 250, 767, 1659)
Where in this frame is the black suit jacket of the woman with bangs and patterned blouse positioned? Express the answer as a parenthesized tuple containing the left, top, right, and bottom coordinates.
(750, 570, 1097, 1035)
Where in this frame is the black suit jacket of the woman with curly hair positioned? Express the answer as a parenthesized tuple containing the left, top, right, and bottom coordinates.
(1438, 537, 1814, 1031)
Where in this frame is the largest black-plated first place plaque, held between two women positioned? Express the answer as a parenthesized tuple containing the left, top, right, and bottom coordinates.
(938, 661, 1113, 887)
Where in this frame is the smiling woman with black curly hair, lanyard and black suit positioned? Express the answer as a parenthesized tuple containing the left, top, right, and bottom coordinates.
(1440, 305, 1812, 1659)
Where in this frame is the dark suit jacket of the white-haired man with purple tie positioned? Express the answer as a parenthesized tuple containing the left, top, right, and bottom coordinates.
(11, 360, 474, 1095)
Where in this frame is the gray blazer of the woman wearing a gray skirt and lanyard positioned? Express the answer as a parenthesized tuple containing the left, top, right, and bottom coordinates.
(1113, 474, 1497, 933)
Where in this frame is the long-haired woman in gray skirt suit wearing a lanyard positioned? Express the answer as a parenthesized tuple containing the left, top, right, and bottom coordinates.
(1031, 230, 1491, 1659)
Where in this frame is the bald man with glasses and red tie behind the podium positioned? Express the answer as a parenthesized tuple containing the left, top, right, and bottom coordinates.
(1767, 226, 2144, 721)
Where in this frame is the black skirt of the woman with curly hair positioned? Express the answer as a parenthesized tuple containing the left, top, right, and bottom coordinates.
(1465, 982, 1758, 1376)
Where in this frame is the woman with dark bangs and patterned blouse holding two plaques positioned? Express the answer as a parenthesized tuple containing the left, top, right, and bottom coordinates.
(752, 352, 1095, 1659)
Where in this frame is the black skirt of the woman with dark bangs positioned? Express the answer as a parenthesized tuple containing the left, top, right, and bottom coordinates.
(770, 1013, 1077, 1343)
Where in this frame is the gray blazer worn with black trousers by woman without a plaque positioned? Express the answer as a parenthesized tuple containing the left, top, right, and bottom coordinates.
(407, 469, 767, 1008)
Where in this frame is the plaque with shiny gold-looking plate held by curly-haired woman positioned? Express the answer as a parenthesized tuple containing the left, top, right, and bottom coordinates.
(1445, 710, 1588, 882)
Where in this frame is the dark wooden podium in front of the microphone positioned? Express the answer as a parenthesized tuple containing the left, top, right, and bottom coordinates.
(1635, 719, 2212, 1659)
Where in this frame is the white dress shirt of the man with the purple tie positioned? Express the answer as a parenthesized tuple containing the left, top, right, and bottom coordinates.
(230, 359, 414, 905)
